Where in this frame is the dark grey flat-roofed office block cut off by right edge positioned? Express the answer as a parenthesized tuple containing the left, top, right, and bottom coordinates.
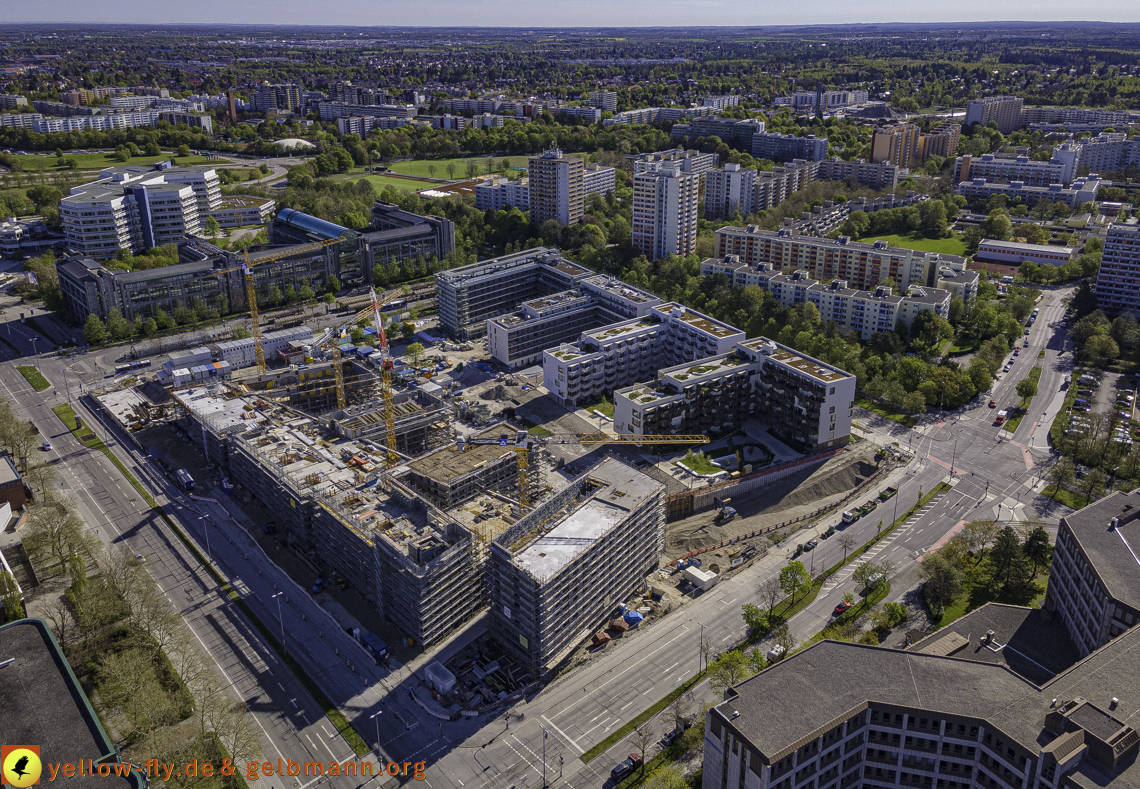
(1042, 491, 1140, 656)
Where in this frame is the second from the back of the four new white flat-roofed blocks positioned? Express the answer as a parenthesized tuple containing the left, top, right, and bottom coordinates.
(487, 275, 661, 369)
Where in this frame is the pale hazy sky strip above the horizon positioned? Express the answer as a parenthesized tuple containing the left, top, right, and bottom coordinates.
(13, 0, 1140, 27)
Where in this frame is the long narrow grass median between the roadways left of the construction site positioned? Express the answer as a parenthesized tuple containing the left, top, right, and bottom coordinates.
(51, 402, 371, 756)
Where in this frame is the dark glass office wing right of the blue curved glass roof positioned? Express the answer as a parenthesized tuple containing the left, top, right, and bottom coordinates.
(357, 200, 455, 280)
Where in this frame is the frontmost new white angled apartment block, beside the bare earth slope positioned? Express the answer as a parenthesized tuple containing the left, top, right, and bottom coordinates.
(613, 337, 855, 450)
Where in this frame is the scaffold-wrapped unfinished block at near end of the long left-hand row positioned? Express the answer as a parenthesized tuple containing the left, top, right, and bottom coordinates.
(312, 467, 486, 645)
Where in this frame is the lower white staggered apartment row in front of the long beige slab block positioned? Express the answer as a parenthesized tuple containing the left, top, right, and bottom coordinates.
(701, 255, 951, 340)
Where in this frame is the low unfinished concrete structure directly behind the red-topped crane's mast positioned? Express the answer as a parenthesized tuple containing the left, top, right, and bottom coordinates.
(333, 389, 455, 456)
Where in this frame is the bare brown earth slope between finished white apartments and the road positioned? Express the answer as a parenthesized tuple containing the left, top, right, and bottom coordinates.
(666, 446, 877, 556)
